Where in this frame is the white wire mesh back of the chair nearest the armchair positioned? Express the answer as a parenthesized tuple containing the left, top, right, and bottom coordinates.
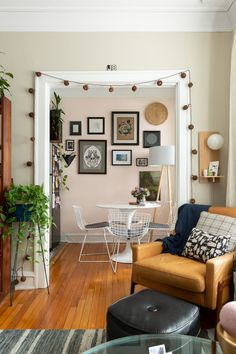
(108, 211, 151, 240)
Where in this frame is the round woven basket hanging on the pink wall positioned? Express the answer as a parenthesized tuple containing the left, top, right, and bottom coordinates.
(145, 102, 168, 125)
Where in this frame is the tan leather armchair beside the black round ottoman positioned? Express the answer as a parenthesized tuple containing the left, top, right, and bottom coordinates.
(131, 207, 236, 311)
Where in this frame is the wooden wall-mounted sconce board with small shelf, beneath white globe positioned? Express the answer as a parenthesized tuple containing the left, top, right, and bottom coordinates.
(198, 131, 224, 183)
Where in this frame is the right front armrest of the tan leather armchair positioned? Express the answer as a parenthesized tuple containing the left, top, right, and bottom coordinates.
(205, 252, 236, 309)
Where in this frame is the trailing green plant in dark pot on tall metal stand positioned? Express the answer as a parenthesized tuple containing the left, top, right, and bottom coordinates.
(0, 184, 51, 303)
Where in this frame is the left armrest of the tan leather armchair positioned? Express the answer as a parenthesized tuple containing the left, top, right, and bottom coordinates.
(132, 242, 162, 262)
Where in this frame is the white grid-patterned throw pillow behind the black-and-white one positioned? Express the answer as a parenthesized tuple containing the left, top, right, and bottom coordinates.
(196, 211, 236, 252)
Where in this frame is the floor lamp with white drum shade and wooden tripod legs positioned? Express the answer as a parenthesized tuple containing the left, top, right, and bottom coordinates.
(148, 145, 175, 224)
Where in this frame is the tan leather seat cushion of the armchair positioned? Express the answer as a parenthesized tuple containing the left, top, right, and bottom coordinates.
(133, 253, 206, 293)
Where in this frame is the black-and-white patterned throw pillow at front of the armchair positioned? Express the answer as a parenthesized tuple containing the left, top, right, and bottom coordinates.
(182, 228, 230, 262)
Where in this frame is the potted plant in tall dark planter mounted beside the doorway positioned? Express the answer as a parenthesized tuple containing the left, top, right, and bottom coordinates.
(50, 92, 65, 143)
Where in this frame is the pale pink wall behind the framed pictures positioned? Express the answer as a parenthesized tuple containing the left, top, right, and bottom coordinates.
(61, 97, 175, 235)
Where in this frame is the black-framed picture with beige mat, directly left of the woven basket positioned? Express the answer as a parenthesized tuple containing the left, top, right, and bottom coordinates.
(112, 112, 139, 145)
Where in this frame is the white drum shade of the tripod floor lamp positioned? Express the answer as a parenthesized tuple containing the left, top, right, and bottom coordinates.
(148, 145, 175, 166)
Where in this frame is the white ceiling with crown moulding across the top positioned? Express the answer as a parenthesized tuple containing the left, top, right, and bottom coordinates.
(0, 0, 236, 32)
